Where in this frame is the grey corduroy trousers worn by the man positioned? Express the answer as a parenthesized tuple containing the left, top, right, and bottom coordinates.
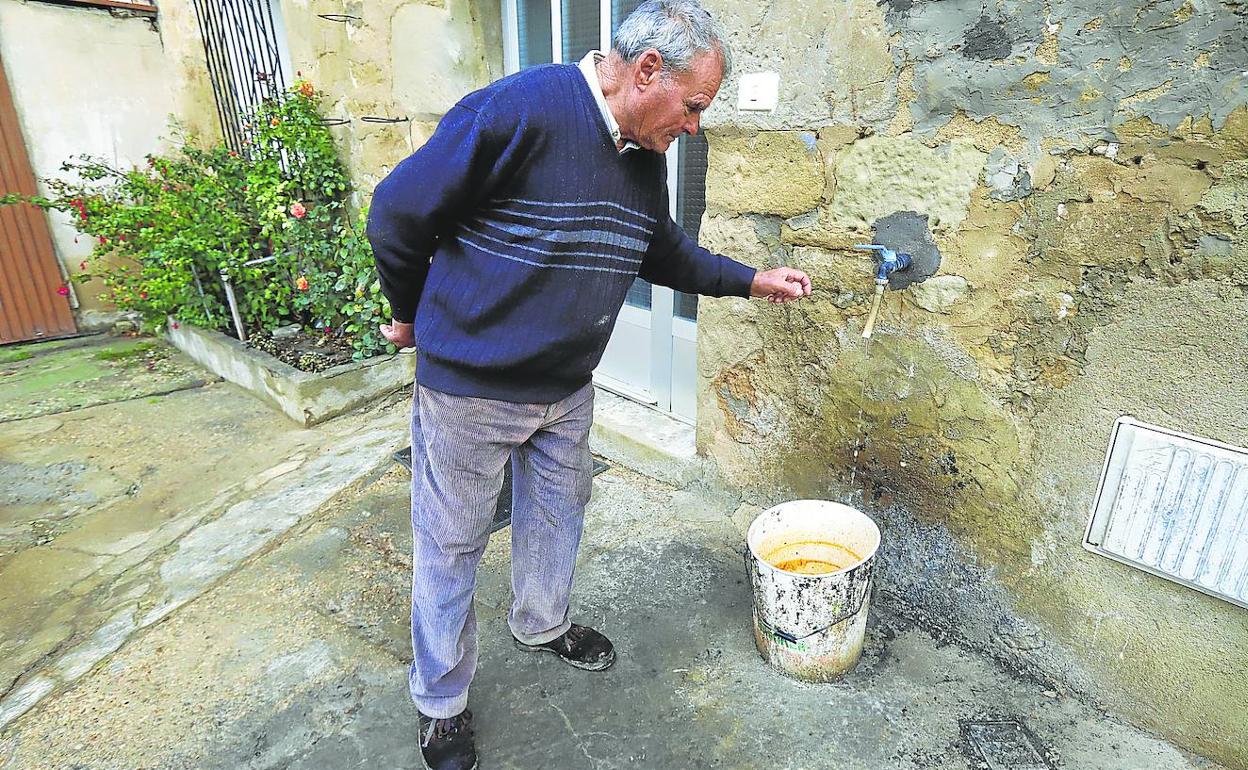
(408, 384, 594, 718)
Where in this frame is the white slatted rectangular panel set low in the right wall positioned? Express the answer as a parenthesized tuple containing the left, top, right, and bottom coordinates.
(1083, 417, 1248, 607)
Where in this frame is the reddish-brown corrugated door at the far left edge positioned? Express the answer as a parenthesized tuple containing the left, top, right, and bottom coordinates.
(0, 49, 77, 344)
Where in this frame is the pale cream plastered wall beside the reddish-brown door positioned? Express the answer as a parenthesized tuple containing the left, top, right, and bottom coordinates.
(0, 1, 180, 328)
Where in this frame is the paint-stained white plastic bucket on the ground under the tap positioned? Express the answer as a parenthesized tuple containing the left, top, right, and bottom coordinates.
(745, 500, 880, 681)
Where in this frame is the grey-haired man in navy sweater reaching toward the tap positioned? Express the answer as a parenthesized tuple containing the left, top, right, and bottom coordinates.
(368, 0, 810, 770)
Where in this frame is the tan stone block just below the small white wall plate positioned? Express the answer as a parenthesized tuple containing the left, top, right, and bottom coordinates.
(706, 131, 824, 217)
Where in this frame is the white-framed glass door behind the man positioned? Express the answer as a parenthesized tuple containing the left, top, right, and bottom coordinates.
(502, 0, 706, 422)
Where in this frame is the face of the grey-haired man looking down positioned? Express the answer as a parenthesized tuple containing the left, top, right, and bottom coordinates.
(629, 54, 723, 152)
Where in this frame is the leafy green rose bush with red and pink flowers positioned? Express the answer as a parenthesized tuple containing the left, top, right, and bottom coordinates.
(0, 81, 393, 358)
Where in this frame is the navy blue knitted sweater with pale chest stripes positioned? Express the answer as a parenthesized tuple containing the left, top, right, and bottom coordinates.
(368, 65, 754, 403)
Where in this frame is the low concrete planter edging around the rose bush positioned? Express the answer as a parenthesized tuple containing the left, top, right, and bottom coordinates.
(166, 318, 416, 427)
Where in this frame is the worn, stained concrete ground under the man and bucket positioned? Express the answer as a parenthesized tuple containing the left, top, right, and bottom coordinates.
(0, 336, 1217, 770)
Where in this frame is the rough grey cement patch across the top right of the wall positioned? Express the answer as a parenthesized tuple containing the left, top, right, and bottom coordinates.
(889, 0, 1248, 147)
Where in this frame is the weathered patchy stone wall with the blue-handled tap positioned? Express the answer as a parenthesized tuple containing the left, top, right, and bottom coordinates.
(698, 0, 1248, 768)
